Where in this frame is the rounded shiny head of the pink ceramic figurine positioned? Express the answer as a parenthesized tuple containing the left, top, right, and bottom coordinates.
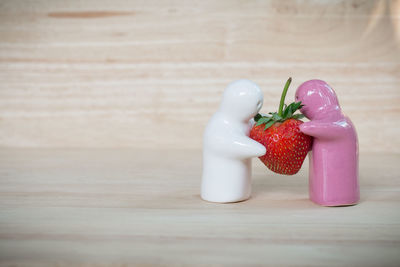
(296, 80, 340, 120)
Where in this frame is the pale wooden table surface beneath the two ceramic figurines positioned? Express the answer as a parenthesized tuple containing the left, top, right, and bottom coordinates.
(0, 149, 400, 266)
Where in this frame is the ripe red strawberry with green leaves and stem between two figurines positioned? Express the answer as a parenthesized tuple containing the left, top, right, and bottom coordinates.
(250, 78, 312, 175)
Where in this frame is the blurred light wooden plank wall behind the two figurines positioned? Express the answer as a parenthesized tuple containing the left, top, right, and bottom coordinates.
(0, 0, 400, 152)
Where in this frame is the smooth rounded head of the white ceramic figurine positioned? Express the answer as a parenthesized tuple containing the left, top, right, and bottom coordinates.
(220, 79, 264, 121)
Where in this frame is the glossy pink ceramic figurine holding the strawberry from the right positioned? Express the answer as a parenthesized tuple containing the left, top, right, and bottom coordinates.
(296, 80, 360, 206)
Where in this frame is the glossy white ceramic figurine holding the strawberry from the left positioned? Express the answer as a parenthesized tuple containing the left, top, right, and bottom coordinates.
(201, 80, 266, 203)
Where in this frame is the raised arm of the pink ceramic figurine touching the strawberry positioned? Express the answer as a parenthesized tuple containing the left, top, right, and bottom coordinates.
(299, 121, 348, 138)
